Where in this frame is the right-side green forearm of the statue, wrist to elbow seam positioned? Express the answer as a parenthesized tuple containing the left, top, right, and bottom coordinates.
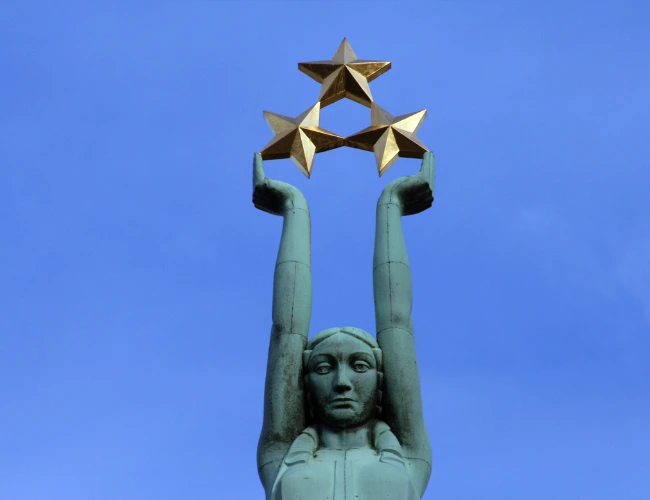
(373, 195, 413, 334)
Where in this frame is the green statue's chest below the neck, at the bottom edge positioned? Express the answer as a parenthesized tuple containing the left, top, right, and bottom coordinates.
(274, 450, 419, 500)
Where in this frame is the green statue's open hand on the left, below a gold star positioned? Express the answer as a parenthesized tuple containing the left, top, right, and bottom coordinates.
(253, 153, 307, 215)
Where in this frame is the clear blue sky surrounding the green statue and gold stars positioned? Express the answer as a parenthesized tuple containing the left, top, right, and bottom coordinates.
(0, 0, 650, 500)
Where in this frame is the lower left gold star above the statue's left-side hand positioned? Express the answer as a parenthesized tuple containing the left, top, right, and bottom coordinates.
(260, 102, 345, 177)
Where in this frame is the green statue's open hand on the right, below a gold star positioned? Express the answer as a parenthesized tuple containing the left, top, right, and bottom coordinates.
(379, 151, 435, 215)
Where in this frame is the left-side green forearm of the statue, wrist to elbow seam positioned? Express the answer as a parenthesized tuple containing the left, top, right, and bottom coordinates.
(272, 195, 312, 339)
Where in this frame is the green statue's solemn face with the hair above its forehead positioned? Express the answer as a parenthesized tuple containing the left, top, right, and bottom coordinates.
(307, 333, 378, 429)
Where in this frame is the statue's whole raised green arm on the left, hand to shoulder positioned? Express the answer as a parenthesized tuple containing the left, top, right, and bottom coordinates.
(253, 154, 312, 493)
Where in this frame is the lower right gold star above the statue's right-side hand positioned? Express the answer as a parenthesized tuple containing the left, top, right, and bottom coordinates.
(345, 102, 428, 177)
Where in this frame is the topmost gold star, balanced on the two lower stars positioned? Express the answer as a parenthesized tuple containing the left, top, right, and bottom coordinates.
(298, 38, 390, 107)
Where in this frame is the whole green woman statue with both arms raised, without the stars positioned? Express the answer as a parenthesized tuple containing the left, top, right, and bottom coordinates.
(253, 153, 434, 500)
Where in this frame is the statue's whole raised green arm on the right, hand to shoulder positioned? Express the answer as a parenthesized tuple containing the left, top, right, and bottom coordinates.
(373, 153, 434, 493)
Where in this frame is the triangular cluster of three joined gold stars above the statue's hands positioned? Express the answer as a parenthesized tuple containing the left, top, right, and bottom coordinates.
(260, 39, 428, 177)
